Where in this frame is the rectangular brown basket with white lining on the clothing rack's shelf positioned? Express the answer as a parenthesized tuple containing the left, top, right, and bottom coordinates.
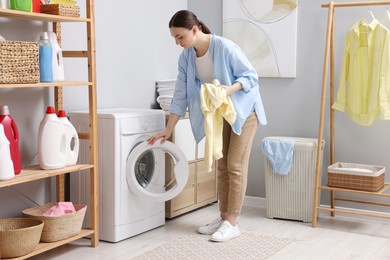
(328, 162, 385, 191)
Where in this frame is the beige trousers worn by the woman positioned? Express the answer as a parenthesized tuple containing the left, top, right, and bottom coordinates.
(217, 112, 259, 214)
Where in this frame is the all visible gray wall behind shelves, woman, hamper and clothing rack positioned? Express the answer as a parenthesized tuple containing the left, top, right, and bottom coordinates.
(0, 0, 390, 215)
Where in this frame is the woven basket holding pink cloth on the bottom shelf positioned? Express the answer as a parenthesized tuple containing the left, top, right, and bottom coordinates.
(22, 203, 87, 242)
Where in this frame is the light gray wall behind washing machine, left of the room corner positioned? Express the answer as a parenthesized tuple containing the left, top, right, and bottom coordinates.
(63, 0, 187, 109)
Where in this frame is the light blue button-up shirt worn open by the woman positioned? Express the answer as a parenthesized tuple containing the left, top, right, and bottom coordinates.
(170, 35, 267, 142)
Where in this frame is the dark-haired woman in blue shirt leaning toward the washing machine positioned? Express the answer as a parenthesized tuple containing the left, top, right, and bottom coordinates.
(148, 10, 267, 242)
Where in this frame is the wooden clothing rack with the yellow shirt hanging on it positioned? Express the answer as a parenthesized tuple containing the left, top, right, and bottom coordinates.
(312, 1, 390, 227)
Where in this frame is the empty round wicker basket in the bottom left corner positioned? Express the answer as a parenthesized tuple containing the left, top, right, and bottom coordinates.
(0, 218, 44, 259)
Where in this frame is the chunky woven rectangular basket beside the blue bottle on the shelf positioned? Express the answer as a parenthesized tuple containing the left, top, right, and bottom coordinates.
(0, 41, 39, 84)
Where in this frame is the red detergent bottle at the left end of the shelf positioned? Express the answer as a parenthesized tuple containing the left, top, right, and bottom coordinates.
(0, 105, 22, 174)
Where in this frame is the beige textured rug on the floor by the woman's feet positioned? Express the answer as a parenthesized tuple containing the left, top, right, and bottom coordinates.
(135, 232, 297, 260)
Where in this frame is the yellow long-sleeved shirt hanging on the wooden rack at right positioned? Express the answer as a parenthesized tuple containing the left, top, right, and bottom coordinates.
(332, 20, 390, 126)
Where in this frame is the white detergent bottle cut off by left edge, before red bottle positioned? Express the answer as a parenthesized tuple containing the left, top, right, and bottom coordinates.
(0, 124, 15, 181)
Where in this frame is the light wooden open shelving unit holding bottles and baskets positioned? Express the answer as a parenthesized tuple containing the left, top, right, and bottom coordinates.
(0, 0, 99, 259)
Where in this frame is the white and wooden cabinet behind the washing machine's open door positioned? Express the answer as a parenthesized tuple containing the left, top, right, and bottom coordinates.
(165, 118, 218, 218)
